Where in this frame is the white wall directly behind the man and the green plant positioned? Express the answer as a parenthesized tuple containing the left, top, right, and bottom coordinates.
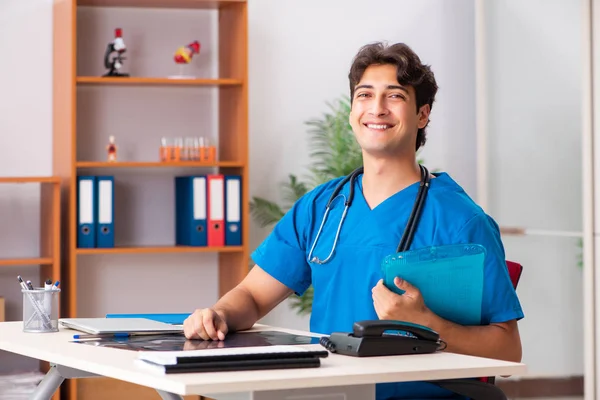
(248, 0, 476, 328)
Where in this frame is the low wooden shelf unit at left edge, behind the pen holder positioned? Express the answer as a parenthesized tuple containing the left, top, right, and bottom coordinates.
(0, 176, 62, 400)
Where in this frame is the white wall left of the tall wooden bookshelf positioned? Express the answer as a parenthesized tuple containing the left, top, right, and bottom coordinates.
(0, 0, 52, 373)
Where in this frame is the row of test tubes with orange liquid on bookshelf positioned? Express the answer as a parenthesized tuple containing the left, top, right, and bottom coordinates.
(159, 137, 217, 163)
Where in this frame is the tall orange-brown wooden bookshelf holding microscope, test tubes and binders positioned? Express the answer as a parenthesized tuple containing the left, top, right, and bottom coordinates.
(52, 0, 250, 400)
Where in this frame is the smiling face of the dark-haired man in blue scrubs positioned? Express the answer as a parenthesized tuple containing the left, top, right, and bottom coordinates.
(350, 64, 430, 157)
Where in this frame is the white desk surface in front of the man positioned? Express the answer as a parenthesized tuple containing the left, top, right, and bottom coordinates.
(0, 322, 526, 395)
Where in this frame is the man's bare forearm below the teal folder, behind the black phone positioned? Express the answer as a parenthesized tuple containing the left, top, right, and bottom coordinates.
(427, 313, 522, 362)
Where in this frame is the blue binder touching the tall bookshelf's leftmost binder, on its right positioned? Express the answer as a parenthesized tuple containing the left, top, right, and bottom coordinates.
(96, 176, 115, 248)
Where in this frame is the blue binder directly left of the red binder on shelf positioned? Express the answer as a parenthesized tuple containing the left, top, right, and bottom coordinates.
(175, 175, 208, 246)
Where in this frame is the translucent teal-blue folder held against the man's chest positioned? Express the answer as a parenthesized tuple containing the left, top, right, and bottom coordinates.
(381, 244, 486, 325)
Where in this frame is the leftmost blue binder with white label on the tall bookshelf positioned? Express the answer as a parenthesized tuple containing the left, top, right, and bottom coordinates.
(77, 176, 96, 248)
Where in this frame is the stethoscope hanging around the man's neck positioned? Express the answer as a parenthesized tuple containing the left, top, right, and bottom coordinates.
(308, 165, 430, 264)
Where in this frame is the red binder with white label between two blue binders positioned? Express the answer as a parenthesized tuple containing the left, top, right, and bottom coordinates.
(206, 174, 225, 247)
